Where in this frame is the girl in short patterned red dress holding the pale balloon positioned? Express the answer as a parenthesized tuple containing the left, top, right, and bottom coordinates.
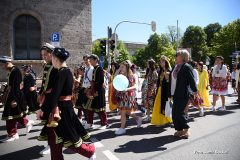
(115, 61, 142, 135)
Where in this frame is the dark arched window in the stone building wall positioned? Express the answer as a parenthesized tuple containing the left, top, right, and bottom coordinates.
(13, 15, 41, 60)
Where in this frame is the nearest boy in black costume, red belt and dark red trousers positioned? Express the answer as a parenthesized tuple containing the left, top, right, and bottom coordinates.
(48, 47, 95, 160)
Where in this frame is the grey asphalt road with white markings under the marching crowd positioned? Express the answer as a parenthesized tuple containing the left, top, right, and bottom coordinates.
(0, 87, 240, 160)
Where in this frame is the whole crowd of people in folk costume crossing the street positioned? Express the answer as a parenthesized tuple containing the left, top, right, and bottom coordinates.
(0, 43, 240, 160)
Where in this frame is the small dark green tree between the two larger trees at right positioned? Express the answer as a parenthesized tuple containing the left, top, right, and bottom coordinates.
(204, 23, 222, 47)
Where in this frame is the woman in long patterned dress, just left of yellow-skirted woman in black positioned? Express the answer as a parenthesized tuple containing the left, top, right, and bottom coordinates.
(143, 59, 158, 121)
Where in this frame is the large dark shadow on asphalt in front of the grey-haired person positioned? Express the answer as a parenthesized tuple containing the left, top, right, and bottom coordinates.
(114, 135, 180, 153)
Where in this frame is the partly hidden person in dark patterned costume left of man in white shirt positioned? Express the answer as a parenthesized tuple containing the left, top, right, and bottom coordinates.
(75, 66, 87, 123)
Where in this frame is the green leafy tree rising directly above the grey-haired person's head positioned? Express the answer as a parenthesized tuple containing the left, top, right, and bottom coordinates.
(182, 26, 207, 61)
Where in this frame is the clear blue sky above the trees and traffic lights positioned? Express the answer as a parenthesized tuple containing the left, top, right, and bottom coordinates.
(92, 0, 240, 43)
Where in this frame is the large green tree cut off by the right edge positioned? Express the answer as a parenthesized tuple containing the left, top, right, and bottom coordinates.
(212, 19, 240, 64)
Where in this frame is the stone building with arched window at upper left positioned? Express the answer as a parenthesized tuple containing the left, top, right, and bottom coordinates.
(0, 0, 92, 80)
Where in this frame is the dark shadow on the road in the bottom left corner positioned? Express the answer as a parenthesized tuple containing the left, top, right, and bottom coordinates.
(0, 146, 44, 160)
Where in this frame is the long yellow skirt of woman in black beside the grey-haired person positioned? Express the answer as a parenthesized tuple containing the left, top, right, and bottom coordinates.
(151, 87, 172, 126)
